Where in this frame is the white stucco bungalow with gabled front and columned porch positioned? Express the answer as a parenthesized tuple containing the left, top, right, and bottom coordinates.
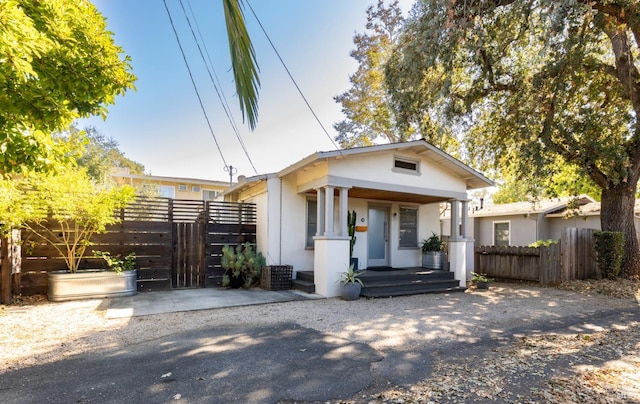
(225, 140, 493, 297)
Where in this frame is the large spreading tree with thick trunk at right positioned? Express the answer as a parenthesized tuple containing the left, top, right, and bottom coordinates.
(387, 0, 640, 274)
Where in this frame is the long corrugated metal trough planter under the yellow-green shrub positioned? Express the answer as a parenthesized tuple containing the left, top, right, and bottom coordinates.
(48, 269, 138, 302)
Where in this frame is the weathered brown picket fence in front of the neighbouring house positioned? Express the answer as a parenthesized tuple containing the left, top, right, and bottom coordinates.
(475, 228, 596, 285)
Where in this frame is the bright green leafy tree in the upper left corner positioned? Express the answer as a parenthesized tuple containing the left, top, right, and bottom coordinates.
(0, 0, 135, 173)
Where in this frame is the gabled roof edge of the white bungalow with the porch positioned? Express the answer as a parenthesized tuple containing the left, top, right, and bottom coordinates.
(278, 140, 495, 189)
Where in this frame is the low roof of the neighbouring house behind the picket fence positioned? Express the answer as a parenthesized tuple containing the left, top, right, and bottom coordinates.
(470, 195, 595, 217)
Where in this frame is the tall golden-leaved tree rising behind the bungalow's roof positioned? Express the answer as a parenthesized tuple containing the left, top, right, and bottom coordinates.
(333, 0, 411, 149)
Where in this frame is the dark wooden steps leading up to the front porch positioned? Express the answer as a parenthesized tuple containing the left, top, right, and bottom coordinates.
(360, 268, 467, 297)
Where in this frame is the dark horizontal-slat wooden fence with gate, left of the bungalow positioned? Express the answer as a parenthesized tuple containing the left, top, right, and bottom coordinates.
(6, 198, 256, 295)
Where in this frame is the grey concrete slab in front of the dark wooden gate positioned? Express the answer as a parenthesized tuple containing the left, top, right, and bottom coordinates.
(105, 288, 324, 318)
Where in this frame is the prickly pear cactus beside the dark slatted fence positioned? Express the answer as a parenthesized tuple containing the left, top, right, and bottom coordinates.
(221, 243, 266, 289)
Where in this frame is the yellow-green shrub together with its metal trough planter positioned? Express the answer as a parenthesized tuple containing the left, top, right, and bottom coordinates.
(21, 167, 137, 301)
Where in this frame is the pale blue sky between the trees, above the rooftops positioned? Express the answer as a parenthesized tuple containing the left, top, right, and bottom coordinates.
(79, 0, 413, 181)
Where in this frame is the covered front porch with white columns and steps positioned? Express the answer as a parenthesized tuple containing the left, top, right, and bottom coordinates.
(310, 178, 474, 297)
